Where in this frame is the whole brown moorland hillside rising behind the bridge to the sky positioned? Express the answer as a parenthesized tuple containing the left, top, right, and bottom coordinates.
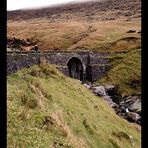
(7, 0, 141, 51)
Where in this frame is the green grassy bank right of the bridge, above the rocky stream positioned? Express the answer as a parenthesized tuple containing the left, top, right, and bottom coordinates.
(98, 49, 141, 95)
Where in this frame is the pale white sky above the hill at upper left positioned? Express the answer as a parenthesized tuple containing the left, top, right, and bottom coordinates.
(7, 0, 89, 10)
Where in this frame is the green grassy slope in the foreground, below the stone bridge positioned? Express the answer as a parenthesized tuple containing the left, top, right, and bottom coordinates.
(7, 65, 141, 148)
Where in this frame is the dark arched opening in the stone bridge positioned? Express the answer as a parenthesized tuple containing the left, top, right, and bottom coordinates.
(67, 57, 83, 81)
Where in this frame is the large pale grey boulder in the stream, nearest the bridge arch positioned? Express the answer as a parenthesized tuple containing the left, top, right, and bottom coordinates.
(93, 86, 108, 96)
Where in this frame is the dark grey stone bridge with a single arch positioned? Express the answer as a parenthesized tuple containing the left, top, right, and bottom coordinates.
(7, 51, 111, 81)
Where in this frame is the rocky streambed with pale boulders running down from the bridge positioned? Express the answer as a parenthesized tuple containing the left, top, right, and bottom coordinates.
(82, 82, 141, 125)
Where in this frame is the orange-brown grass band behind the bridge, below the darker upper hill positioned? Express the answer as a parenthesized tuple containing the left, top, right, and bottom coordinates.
(8, 19, 141, 51)
